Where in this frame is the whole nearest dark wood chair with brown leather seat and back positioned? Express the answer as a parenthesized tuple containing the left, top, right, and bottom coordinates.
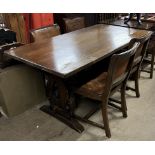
(76, 40, 139, 138)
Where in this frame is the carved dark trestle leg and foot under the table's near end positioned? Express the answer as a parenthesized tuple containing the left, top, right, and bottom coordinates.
(40, 75, 84, 133)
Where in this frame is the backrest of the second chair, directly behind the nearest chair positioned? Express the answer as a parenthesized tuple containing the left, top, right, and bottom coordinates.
(129, 35, 151, 67)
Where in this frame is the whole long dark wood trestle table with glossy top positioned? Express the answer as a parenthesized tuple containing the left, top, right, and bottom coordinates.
(5, 24, 151, 132)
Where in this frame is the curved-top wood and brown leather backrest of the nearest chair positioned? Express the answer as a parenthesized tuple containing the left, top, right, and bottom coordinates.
(103, 42, 140, 98)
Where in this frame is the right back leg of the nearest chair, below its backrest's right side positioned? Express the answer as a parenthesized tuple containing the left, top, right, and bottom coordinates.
(121, 84, 127, 118)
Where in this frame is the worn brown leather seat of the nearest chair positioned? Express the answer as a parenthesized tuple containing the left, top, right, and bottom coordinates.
(76, 72, 107, 100)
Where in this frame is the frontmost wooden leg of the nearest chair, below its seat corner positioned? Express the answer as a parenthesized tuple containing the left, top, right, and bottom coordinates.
(102, 103, 111, 138)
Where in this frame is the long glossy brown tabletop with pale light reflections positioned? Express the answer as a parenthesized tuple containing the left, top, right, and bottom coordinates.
(5, 24, 151, 78)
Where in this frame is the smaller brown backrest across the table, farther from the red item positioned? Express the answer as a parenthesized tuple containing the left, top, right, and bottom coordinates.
(63, 17, 85, 32)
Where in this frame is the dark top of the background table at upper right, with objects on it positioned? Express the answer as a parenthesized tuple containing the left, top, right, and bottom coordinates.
(105, 19, 155, 30)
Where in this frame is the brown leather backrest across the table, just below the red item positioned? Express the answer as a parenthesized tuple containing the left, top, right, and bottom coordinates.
(30, 25, 60, 42)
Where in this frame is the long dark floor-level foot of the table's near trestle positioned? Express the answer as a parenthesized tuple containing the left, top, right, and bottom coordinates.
(40, 105, 84, 133)
